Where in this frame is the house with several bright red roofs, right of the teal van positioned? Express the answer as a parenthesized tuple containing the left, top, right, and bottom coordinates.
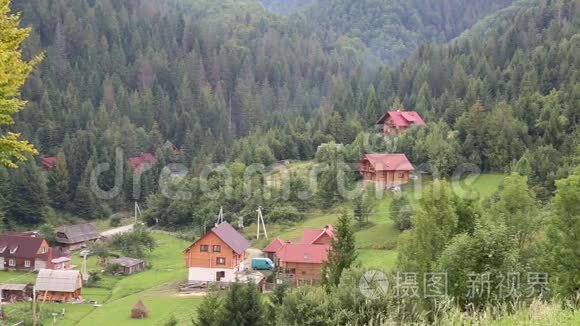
(263, 225, 335, 285)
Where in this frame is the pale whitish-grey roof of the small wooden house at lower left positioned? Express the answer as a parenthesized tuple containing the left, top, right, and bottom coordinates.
(35, 269, 83, 292)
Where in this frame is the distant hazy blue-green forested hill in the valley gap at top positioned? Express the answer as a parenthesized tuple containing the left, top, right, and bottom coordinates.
(286, 0, 512, 64)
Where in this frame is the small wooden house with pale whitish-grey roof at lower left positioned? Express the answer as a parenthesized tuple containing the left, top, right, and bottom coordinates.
(35, 269, 83, 302)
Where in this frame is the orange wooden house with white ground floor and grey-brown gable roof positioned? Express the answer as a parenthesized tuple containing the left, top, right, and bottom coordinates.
(183, 222, 250, 282)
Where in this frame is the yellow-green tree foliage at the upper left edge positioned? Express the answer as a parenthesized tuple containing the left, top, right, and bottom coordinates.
(0, 0, 41, 168)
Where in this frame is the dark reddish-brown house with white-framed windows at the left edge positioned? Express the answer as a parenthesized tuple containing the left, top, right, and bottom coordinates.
(0, 233, 66, 271)
